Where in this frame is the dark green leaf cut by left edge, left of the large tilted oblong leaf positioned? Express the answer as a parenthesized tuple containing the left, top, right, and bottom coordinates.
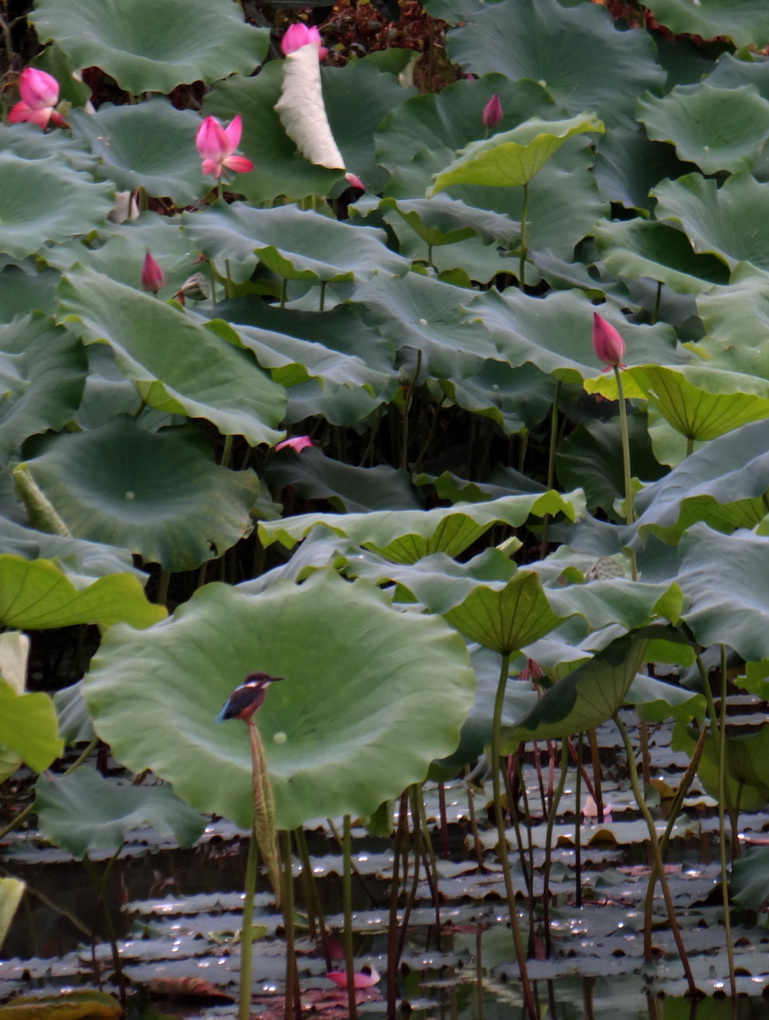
(0, 314, 87, 459)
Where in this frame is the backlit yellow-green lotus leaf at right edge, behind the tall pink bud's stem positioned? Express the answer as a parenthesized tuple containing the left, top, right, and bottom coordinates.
(584, 365, 769, 442)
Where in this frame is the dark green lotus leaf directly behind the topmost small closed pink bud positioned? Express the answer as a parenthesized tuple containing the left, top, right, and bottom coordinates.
(376, 74, 550, 199)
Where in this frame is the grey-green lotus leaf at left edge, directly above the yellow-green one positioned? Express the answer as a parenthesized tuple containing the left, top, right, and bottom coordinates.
(0, 516, 147, 582)
